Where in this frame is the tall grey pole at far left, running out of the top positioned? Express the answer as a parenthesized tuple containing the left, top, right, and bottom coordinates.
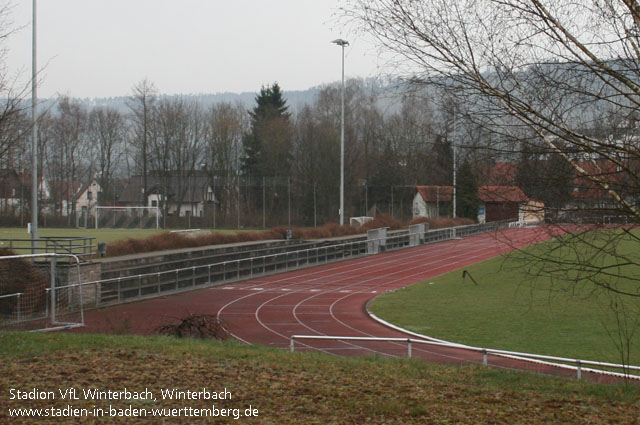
(31, 0, 38, 254)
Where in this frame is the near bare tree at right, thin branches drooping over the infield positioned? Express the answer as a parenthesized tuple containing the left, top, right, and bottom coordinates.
(346, 0, 640, 368)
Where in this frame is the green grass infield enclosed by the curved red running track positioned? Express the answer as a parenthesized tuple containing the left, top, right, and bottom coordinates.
(372, 232, 640, 365)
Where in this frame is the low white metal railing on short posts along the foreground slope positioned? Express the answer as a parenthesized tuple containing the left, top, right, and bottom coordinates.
(289, 335, 640, 380)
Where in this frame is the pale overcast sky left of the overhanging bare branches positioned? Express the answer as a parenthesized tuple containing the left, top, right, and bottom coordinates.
(7, 0, 378, 97)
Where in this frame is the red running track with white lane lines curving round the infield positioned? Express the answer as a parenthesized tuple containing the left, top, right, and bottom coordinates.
(77, 228, 612, 382)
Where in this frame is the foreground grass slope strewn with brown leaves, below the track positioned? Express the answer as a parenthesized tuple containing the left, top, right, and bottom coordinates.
(0, 332, 640, 424)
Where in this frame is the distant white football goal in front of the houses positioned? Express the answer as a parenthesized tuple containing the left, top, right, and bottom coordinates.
(96, 206, 160, 229)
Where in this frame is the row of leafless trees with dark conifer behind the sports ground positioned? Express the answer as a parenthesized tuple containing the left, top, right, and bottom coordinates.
(2, 79, 500, 227)
